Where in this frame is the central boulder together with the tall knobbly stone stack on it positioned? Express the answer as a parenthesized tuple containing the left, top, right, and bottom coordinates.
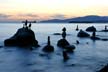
(57, 27, 70, 47)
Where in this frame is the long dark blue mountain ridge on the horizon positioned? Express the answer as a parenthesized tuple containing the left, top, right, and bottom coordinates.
(41, 15, 108, 23)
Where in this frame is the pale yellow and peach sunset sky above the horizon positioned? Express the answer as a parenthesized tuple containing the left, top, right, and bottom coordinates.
(0, 0, 108, 21)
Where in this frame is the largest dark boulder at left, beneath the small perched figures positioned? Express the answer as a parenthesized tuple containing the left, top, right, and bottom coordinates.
(4, 28, 39, 47)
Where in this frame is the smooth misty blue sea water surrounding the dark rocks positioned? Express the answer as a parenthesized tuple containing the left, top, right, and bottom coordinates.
(0, 23, 108, 72)
